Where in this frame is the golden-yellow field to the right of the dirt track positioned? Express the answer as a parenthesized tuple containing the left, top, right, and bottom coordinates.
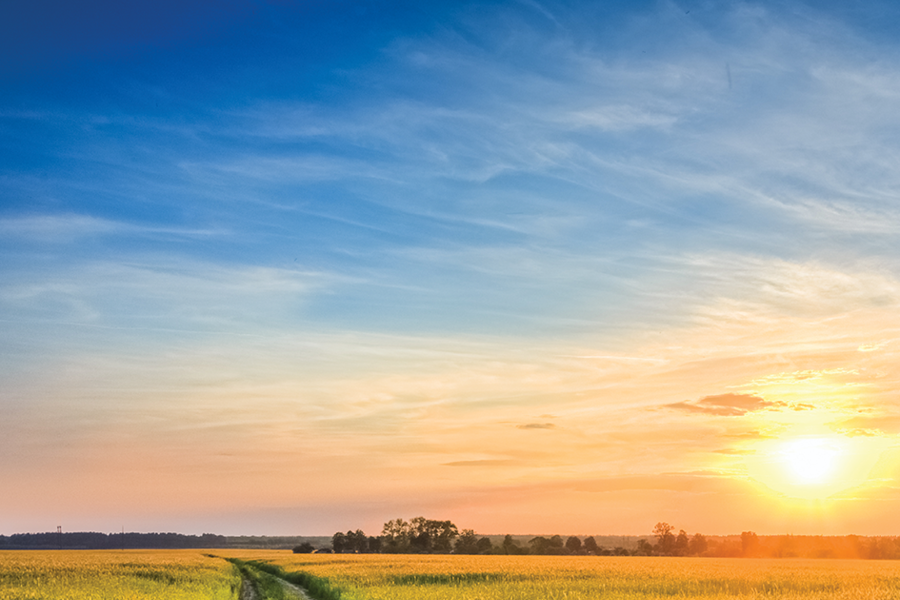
(220, 552, 900, 600)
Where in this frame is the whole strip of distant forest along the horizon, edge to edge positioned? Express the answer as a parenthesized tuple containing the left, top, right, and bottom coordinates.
(7, 517, 900, 559)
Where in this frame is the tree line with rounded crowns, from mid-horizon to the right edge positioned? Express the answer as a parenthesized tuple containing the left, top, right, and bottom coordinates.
(304, 517, 900, 559)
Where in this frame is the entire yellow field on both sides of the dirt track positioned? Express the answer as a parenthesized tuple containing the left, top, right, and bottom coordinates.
(0, 550, 900, 600)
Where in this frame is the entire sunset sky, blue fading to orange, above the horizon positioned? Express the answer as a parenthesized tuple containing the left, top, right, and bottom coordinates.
(0, 0, 900, 535)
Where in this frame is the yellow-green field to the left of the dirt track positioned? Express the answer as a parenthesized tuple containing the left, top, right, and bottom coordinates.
(0, 550, 241, 600)
